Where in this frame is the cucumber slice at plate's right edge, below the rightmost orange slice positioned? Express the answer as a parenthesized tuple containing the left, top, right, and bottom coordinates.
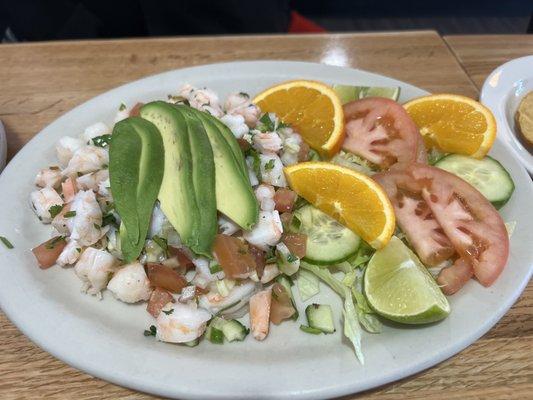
(435, 154, 514, 208)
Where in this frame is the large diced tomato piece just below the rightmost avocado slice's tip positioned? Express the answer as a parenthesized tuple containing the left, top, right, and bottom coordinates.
(213, 234, 256, 279)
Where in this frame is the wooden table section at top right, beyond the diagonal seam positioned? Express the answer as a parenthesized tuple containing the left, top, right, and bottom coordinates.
(444, 35, 533, 90)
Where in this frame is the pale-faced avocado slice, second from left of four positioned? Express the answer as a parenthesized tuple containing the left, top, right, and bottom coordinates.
(140, 101, 200, 249)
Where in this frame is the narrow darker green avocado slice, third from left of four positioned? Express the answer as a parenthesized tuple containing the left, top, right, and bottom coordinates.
(178, 109, 217, 258)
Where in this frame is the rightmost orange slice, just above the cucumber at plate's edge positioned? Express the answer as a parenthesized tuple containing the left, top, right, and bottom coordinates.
(404, 94, 496, 158)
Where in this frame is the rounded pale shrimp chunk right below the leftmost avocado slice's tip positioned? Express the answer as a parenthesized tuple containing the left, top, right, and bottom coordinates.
(107, 262, 152, 303)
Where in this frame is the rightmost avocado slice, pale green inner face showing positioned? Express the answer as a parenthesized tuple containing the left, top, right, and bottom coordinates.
(176, 105, 259, 230)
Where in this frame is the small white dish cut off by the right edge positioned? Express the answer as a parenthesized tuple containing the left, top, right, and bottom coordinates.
(480, 55, 533, 174)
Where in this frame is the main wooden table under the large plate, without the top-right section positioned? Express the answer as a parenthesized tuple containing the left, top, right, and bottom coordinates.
(0, 31, 533, 400)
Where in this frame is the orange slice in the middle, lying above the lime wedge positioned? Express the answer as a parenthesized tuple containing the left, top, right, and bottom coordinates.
(285, 162, 396, 249)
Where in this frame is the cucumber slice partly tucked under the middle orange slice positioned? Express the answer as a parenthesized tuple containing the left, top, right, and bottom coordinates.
(292, 205, 361, 265)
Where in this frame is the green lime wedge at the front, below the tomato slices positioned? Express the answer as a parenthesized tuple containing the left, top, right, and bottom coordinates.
(364, 236, 450, 324)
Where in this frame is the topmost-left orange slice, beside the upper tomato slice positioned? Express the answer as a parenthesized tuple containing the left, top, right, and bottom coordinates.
(254, 80, 344, 157)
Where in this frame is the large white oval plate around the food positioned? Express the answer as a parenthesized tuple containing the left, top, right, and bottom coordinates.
(0, 61, 533, 399)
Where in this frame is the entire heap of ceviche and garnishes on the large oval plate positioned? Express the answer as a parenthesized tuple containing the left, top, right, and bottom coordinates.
(22, 80, 514, 362)
